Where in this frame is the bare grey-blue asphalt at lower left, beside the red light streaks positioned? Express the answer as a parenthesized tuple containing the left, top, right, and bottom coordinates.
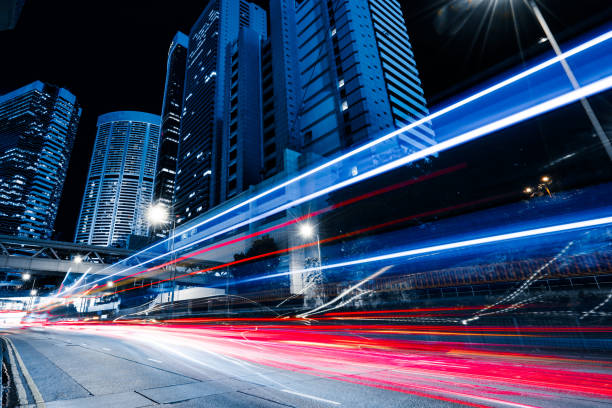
(3, 329, 458, 408)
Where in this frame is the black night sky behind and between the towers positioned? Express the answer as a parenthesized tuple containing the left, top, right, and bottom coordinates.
(0, 0, 612, 240)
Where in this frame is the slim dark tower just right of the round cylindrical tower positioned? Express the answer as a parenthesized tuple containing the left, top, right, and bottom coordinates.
(153, 31, 189, 228)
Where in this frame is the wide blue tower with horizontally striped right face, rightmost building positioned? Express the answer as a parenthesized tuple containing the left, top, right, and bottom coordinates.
(296, 0, 435, 156)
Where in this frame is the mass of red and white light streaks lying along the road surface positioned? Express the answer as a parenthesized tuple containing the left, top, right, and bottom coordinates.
(44, 322, 612, 407)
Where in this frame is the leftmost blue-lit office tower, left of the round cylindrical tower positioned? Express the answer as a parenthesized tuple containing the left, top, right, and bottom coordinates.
(0, 81, 81, 239)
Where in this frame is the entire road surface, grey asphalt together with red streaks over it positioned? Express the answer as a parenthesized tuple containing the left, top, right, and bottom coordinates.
(3, 325, 612, 408)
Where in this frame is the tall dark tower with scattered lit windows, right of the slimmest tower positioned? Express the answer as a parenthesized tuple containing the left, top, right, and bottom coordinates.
(174, 0, 267, 223)
